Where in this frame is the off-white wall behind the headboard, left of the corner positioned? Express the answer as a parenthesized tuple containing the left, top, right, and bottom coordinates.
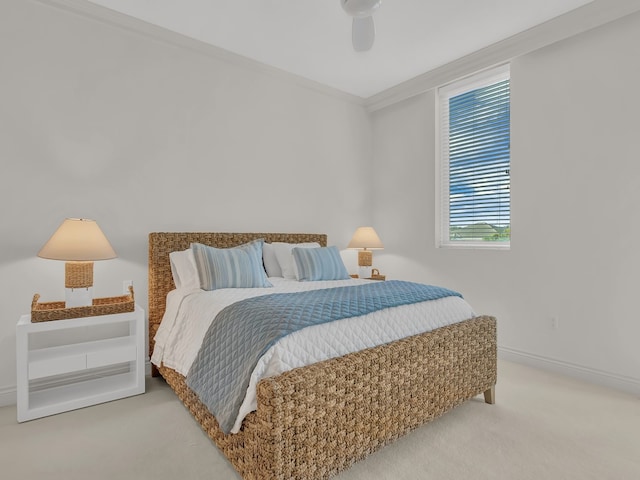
(0, 0, 371, 399)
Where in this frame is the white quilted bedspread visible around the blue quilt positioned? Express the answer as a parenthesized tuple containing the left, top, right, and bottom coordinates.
(151, 277, 474, 433)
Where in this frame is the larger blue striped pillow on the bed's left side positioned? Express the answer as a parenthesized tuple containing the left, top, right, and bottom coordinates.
(191, 239, 273, 290)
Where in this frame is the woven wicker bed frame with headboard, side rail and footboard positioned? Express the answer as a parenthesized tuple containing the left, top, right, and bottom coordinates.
(149, 232, 497, 480)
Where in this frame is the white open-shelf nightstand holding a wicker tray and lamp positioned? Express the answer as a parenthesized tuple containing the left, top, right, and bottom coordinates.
(16, 305, 145, 422)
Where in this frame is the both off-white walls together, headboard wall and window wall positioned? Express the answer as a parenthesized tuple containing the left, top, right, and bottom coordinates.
(0, 0, 640, 403)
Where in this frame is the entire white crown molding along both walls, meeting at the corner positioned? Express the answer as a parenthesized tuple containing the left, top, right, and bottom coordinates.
(32, 0, 640, 113)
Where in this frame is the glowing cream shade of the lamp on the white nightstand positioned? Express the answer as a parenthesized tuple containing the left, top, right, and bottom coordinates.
(38, 218, 117, 262)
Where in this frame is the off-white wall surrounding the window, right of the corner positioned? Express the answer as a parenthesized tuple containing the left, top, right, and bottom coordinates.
(373, 14, 640, 392)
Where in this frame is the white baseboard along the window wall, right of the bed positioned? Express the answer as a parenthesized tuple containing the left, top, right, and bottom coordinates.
(498, 347, 640, 395)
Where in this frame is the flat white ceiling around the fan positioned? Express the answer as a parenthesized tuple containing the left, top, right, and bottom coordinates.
(90, 0, 590, 98)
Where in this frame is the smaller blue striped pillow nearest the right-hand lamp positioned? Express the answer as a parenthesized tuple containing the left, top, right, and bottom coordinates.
(291, 247, 351, 281)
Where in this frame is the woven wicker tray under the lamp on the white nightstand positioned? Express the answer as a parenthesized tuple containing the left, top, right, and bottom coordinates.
(31, 285, 135, 322)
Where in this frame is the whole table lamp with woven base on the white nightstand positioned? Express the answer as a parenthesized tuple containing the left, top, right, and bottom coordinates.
(38, 218, 117, 308)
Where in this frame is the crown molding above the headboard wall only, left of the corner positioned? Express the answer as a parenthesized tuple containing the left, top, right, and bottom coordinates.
(32, 0, 365, 107)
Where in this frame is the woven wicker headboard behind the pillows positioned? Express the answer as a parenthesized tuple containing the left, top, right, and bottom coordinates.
(149, 232, 327, 355)
